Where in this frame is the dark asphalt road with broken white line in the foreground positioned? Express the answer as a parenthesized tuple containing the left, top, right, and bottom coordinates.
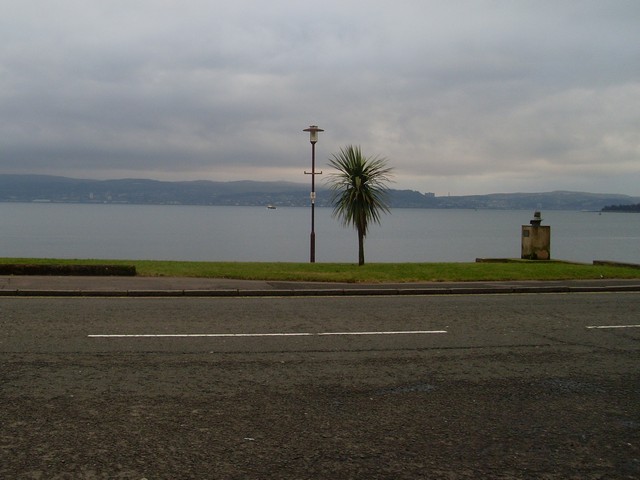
(0, 293, 640, 480)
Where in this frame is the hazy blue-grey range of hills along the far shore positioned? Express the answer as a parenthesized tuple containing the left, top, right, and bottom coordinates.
(0, 175, 640, 211)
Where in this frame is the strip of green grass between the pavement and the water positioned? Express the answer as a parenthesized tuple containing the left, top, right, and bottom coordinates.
(0, 258, 640, 283)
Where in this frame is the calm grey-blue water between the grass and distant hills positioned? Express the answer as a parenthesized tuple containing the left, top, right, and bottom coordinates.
(0, 203, 640, 263)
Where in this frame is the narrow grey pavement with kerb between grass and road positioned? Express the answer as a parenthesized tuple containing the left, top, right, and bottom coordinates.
(0, 275, 640, 296)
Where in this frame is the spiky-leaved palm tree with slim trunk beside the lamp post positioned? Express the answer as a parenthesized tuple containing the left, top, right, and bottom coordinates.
(328, 145, 392, 265)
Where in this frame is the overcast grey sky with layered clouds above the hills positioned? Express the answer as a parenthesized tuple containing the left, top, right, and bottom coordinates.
(0, 0, 640, 195)
